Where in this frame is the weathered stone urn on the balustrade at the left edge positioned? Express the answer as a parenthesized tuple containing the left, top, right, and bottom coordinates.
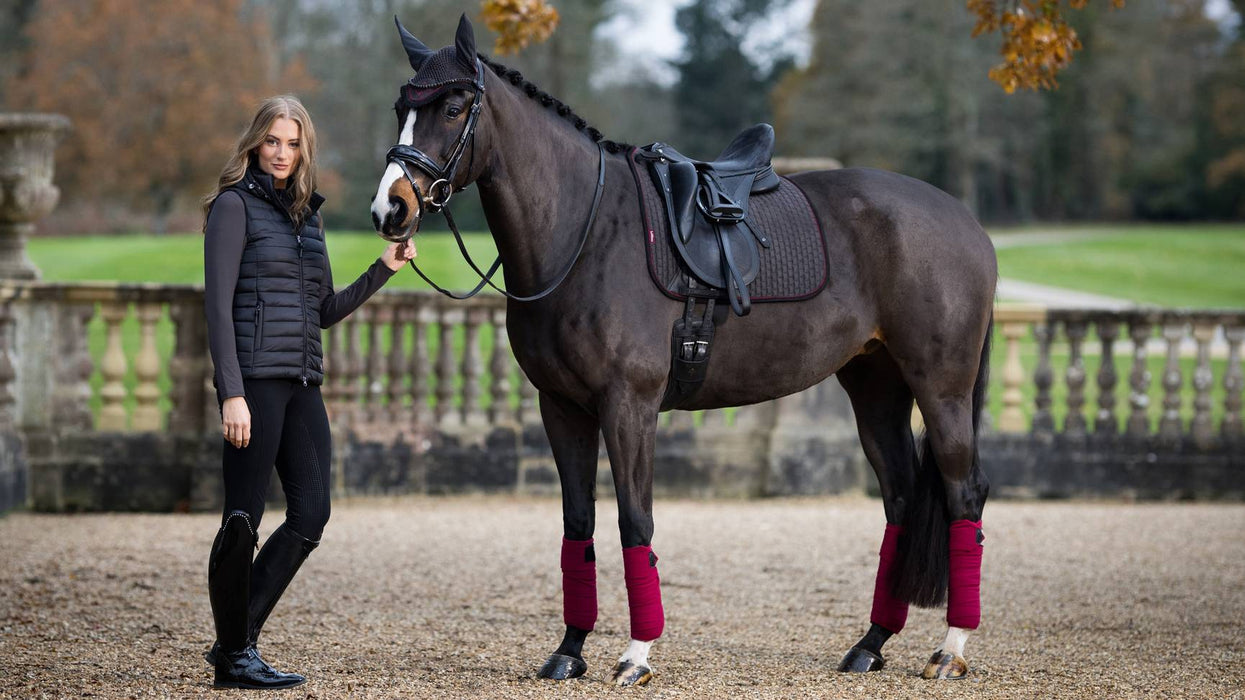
(0, 113, 70, 279)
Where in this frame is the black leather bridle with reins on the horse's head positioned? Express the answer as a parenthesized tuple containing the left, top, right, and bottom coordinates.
(385, 57, 605, 301)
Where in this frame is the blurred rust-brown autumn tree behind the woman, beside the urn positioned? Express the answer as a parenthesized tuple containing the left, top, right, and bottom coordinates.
(6, 0, 314, 232)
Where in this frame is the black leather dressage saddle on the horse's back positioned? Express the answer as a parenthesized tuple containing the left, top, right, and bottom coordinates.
(636, 123, 781, 316)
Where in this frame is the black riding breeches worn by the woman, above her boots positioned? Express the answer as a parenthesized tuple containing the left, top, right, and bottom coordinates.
(223, 379, 332, 541)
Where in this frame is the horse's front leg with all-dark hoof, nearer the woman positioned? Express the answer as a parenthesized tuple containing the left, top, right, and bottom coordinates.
(537, 394, 600, 680)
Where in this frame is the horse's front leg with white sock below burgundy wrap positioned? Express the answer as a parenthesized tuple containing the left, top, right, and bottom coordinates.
(601, 397, 666, 686)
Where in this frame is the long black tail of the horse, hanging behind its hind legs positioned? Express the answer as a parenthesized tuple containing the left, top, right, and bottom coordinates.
(891, 311, 995, 608)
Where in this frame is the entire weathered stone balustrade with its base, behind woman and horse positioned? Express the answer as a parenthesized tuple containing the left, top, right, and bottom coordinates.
(0, 281, 1245, 509)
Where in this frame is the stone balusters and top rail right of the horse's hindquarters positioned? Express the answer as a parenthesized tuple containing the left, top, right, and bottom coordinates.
(992, 304, 1245, 448)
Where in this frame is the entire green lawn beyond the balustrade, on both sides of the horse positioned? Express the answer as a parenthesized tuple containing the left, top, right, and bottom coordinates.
(29, 224, 1245, 308)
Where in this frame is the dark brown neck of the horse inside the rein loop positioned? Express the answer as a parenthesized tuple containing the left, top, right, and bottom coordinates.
(478, 86, 607, 294)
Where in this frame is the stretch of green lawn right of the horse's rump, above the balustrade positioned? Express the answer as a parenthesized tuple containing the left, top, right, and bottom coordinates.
(991, 224, 1245, 309)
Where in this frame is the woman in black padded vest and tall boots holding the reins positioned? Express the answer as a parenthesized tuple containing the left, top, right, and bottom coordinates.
(203, 96, 415, 688)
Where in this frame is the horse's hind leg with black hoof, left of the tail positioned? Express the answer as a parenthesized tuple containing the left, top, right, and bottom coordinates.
(837, 348, 916, 673)
